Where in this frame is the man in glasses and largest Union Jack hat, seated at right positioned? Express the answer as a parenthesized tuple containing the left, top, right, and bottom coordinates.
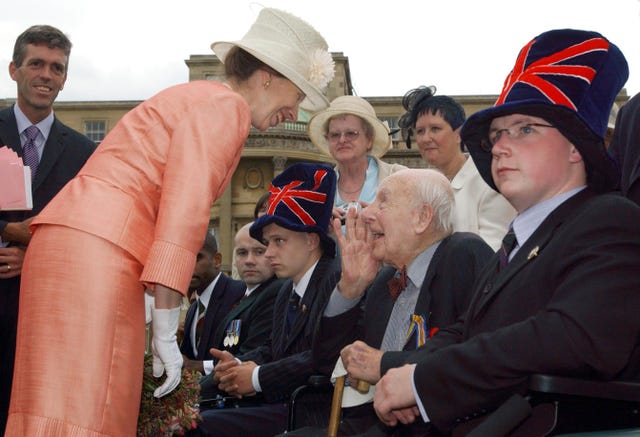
(368, 29, 640, 432)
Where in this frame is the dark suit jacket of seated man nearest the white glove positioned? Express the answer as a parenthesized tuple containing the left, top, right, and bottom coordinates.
(180, 273, 246, 361)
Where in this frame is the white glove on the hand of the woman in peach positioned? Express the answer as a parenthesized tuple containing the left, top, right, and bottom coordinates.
(151, 307, 182, 398)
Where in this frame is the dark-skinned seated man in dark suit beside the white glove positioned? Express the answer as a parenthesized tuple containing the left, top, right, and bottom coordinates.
(180, 232, 245, 375)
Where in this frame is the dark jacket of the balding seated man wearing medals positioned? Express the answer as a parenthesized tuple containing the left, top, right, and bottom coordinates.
(212, 276, 284, 355)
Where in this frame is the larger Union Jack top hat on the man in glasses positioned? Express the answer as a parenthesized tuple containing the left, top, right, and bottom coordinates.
(461, 29, 629, 191)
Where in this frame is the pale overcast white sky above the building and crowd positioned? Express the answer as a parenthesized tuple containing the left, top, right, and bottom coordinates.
(0, 0, 640, 101)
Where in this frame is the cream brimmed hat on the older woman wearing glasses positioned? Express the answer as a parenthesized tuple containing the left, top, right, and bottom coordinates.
(307, 96, 391, 158)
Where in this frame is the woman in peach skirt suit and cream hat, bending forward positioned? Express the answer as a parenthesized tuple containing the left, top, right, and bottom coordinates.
(6, 9, 333, 437)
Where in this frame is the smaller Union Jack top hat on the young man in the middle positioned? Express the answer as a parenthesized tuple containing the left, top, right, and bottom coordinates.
(249, 163, 336, 257)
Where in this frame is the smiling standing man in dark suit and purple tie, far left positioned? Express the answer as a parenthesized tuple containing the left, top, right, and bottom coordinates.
(0, 26, 96, 434)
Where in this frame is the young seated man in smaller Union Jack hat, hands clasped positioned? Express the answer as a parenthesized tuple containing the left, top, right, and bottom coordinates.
(202, 164, 340, 436)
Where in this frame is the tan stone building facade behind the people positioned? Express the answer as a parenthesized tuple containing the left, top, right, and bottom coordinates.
(0, 52, 628, 272)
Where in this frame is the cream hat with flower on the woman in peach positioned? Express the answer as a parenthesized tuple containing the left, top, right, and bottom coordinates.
(211, 8, 334, 111)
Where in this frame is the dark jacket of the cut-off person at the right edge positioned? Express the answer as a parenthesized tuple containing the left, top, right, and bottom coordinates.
(609, 90, 640, 205)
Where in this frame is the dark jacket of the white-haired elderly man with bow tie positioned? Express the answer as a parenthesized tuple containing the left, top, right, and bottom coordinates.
(314, 232, 493, 374)
